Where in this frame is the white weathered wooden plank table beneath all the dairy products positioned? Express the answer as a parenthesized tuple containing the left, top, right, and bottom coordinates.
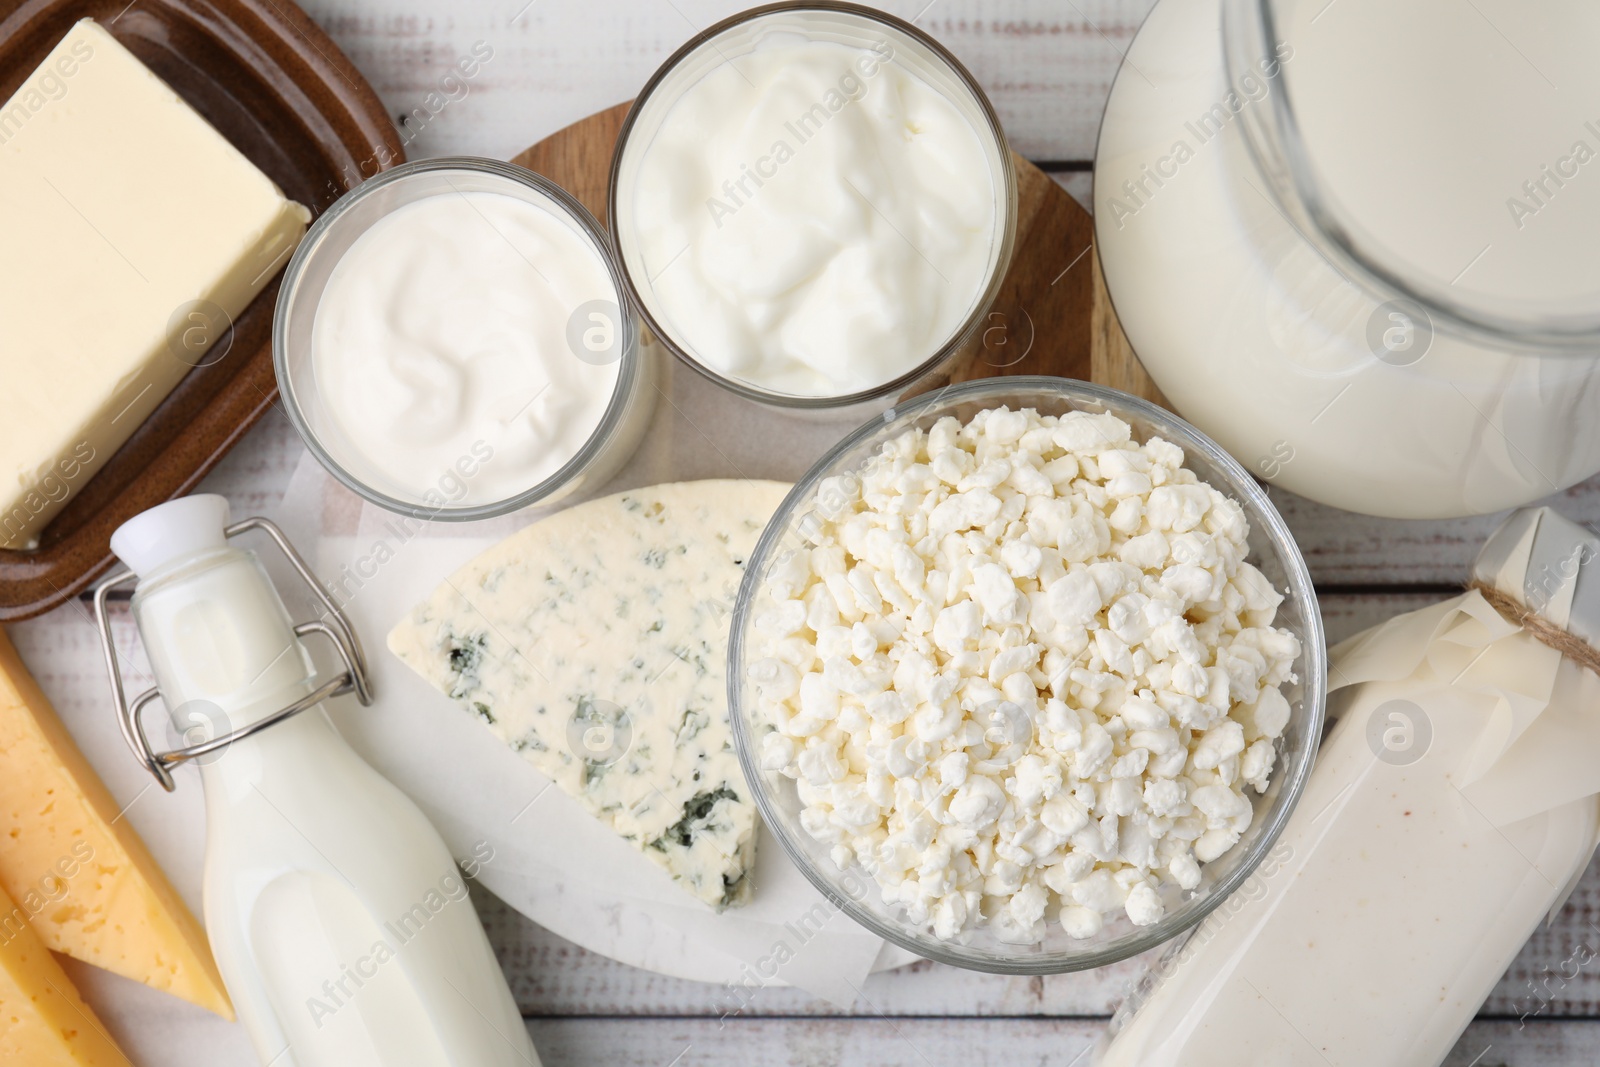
(11, 0, 1600, 1067)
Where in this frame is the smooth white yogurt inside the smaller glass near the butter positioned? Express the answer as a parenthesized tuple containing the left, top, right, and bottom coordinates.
(312, 190, 621, 507)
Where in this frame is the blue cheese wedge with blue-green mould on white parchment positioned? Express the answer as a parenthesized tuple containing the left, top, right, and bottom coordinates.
(389, 482, 789, 909)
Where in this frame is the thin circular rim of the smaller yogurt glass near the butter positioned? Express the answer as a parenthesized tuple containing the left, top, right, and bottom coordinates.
(272, 155, 642, 522)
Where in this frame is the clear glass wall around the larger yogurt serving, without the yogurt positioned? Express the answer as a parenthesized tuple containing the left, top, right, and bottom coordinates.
(608, 0, 1018, 411)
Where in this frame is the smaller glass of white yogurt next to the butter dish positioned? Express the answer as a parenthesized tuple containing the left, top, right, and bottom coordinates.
(272, 158, 656, 520)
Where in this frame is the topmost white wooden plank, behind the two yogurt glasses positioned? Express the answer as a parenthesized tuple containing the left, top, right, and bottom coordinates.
(301, 0, 1152, 160)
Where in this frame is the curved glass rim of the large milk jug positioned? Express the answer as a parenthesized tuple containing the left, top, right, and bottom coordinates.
(1221, 0, 1600, 354)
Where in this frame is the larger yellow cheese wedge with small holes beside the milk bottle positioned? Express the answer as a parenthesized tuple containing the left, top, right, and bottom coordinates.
(0, 632, 234, 1023)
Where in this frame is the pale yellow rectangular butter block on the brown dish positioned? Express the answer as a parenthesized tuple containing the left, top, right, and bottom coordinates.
(0, 19, 310, 549)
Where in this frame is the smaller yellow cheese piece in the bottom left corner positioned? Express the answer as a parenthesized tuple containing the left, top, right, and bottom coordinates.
(0, 891, 133, 1067)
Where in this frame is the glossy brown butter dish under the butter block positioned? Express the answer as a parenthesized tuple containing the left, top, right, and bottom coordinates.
(0, 0, 405, 621)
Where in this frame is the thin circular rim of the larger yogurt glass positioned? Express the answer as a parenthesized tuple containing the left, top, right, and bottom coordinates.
(606, 0, 1018, 411)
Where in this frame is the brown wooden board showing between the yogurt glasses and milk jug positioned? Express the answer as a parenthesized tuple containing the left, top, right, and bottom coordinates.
(512, 104, 1170, 406)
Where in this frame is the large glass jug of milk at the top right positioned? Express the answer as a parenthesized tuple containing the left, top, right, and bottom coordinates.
(1094, 0, 1600, 517)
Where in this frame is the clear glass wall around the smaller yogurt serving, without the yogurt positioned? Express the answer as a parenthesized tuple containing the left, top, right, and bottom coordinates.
(272, 157, 656, 522)
